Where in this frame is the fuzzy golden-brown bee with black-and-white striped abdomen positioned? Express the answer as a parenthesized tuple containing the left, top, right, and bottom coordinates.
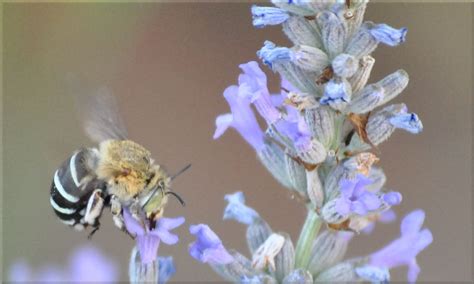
(50, 88, 190, 238)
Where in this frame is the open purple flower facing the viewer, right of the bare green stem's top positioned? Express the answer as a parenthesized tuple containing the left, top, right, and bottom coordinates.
(336, 174, 382, 216)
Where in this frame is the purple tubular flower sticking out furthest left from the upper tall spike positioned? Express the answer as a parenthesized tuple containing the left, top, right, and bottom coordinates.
(213, 85, 264, 151)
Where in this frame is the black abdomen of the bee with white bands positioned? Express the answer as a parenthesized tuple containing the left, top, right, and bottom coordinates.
(50, 149, 105, 230)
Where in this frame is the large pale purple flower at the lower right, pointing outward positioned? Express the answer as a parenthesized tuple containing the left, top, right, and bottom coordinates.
(369, 209, 433, 283)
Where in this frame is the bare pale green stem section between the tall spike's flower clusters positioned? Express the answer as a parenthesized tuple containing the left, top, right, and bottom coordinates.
(295, 209, 322, 268)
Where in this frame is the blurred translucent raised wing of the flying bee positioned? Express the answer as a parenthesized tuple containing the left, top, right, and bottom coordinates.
(76, 84, 128, 143)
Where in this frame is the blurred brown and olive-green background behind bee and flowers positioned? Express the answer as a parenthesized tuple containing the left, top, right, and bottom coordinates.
(2, 3, 474, 282)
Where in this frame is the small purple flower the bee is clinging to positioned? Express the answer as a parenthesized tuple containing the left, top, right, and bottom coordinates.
(123, 209, 184, 264)
